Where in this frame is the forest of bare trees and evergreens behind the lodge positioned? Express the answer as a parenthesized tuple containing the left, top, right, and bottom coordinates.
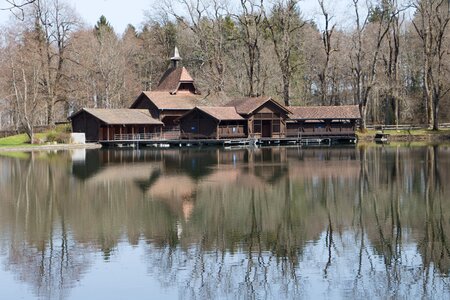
(0, 0, 450, 132)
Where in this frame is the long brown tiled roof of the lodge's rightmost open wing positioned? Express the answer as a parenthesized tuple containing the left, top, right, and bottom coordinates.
(289, 105, 361, 120)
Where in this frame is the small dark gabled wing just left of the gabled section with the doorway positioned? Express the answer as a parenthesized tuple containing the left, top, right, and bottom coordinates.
(178, 106, 248, 139)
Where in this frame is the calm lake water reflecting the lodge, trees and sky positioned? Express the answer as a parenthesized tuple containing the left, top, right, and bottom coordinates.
(0, 146, 450, 299)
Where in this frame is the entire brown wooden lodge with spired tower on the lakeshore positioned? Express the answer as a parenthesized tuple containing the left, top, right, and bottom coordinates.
(70, 50, 360, 145)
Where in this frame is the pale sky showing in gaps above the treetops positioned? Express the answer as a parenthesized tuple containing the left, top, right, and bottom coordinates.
(0, 0, 354, 34)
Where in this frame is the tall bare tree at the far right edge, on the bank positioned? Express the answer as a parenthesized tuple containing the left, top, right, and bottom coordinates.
(413, 0, 450, 130)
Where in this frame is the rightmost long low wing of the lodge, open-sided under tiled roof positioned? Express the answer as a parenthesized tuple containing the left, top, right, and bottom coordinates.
(287, 105, 361, 137)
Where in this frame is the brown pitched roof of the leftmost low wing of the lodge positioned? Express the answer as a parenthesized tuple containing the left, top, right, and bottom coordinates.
(69, 108, 163, 125)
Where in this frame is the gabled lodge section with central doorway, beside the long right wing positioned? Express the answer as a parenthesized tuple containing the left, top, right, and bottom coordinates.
(228, 97, 290, 138)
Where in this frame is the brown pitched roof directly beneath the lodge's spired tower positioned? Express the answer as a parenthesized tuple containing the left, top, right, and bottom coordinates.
(131, 91, 201, 110)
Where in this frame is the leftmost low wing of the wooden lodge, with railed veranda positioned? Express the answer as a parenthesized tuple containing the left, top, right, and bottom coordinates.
(69, 108, 163, 142)
